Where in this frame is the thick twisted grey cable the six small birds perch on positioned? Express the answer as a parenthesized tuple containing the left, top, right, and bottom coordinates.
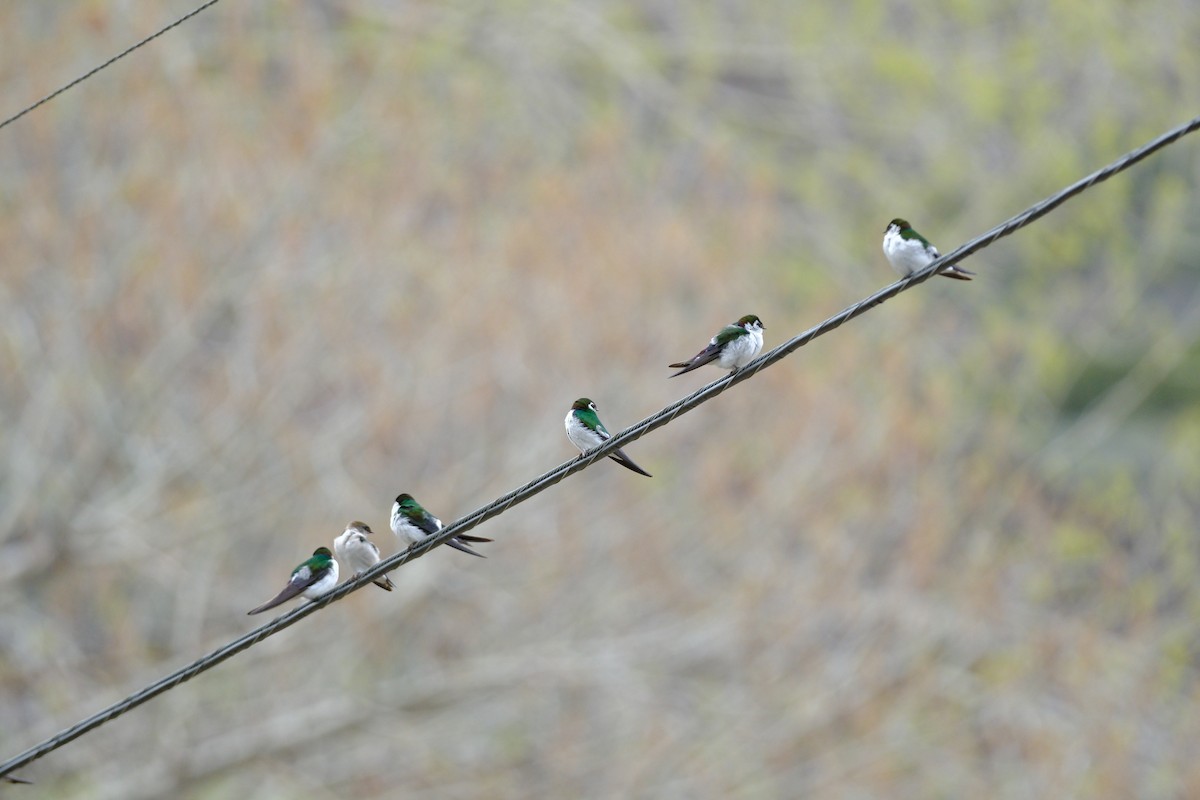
(0, 116, 1200, 777)
